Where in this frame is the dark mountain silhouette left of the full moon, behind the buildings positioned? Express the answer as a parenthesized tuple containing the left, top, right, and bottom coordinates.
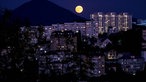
(13, 0, 86, 25)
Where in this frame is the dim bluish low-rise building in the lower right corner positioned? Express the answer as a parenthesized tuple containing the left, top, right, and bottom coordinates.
(118, 54, 145, 75)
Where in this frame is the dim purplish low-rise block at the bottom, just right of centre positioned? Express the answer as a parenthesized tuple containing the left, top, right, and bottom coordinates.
(85, 56, 105, 77)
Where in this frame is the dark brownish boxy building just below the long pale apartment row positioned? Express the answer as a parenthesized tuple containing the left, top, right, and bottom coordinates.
(50, 31, 77, 52)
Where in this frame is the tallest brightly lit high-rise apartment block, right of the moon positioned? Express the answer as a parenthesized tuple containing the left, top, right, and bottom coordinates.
(90, 12, 132, 34)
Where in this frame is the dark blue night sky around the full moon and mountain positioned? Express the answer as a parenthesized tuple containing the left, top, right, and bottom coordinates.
(0, 0, 146, 19)
